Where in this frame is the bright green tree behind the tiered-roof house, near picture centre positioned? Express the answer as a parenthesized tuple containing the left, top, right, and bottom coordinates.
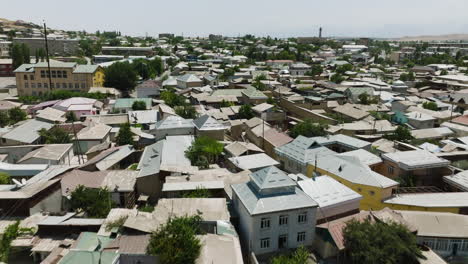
(185, 136, 224, 168)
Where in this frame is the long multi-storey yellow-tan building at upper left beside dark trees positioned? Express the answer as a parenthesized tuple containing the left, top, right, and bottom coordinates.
(14, 60, 104, 96)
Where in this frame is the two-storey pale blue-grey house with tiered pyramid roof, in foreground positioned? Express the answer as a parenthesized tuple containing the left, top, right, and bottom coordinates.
(232, 166, 318, 255)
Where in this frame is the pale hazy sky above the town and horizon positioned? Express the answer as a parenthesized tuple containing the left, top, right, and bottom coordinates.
(0, 0, 468, 38)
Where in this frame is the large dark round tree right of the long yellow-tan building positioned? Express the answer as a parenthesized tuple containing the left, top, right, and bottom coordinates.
(104, 62, 137, 96)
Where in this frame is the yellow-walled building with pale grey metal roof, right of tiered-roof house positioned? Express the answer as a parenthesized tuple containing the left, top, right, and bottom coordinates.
(307, 153, 398, 210)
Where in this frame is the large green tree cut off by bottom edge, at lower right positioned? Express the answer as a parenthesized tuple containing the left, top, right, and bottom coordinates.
(343, 219, 425, 264)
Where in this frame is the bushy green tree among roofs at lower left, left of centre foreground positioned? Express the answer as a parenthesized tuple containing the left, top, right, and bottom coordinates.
(70, 185, 112, 218)
